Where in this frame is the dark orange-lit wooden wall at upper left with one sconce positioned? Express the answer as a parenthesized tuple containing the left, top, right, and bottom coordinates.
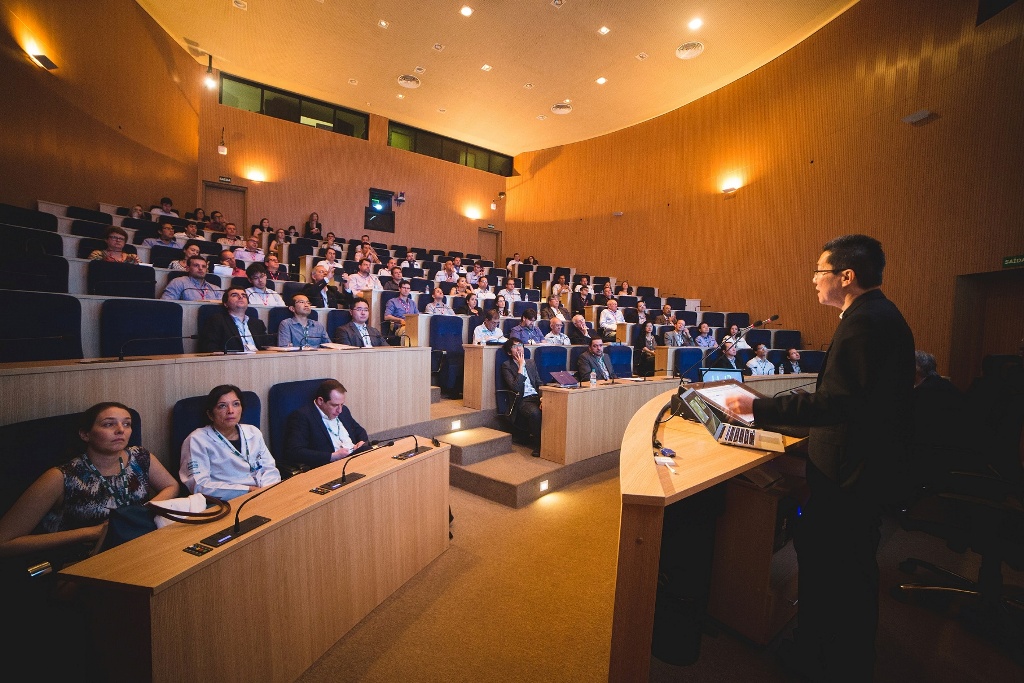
(0, 0, 203, 208)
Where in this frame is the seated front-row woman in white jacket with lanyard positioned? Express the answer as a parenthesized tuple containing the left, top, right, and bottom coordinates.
(178, 384, 281, 501)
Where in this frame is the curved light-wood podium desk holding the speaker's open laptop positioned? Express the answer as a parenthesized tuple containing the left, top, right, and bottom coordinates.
(606, 393, 799, 681)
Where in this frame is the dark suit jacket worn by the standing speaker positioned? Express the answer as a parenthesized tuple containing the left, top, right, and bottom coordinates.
(754, 289, 914, 498)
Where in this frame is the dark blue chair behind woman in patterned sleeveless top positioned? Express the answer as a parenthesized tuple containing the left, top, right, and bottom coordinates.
(0, 407, 142, 516)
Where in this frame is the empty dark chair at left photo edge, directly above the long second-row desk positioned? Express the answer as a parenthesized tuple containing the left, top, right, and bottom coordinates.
(0, 291, 82, 362)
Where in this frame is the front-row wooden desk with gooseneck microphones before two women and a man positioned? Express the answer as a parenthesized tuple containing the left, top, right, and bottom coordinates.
(61, 437, 450, 681)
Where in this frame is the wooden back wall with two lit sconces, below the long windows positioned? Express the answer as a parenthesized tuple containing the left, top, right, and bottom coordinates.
(193, 101, 505, 252)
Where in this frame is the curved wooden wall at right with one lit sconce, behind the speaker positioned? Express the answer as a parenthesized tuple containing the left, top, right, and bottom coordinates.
(505, 0, 1024, 371)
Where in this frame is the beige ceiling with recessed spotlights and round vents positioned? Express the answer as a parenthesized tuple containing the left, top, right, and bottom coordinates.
(137, 0, 856, 155)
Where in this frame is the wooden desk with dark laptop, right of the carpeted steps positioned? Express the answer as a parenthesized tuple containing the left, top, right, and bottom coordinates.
(536, 378, 675, 465)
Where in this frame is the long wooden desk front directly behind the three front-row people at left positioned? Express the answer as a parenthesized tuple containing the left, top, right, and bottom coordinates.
(0, 346, 430, 464)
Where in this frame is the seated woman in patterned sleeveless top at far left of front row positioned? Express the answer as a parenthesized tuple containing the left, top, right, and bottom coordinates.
(0, 402, 178, 560)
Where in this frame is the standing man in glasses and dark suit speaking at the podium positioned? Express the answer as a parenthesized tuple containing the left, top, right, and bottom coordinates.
(726, 234, 914, 681)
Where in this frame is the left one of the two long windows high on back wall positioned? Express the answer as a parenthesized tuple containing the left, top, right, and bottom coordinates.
(220, 73, 370, 140)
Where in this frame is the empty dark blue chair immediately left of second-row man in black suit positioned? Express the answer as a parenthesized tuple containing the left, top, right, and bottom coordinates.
(99, 299, 185, 358)
